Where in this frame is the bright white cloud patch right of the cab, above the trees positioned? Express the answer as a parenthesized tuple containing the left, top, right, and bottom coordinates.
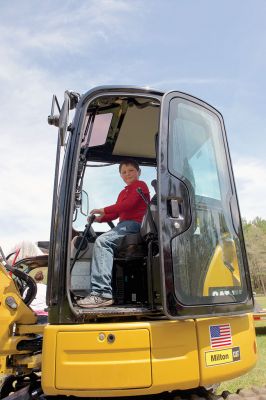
(233, 157, 266, 221)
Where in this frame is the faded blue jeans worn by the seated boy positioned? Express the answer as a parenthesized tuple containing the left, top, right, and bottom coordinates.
(91, 221, 140, 299)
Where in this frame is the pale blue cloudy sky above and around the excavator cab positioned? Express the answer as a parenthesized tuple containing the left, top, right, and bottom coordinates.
(0, 0, 266, 252)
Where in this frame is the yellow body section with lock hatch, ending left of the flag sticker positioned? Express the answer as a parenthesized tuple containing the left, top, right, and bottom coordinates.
(42, 320, 199, 397)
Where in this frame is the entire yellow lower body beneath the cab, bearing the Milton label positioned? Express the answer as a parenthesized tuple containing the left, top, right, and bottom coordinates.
(42, 315, 257, 397)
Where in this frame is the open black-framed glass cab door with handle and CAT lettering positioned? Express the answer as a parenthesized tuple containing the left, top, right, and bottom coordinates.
(158, 92, 253, 318)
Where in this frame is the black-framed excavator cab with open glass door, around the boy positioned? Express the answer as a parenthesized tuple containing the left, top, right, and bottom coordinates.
(48, 88, 253, 322)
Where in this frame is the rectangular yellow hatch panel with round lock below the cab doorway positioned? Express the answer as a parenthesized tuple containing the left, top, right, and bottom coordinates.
(55, 329, 151, 390)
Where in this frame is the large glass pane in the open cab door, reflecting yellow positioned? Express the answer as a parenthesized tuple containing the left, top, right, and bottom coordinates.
(168, 98, 247, 304)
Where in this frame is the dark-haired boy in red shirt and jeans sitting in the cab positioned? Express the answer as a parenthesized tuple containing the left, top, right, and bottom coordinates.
(77, 159, 150, 308)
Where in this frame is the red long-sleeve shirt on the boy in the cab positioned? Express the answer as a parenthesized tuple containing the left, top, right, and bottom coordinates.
(101, 180, 150, 222)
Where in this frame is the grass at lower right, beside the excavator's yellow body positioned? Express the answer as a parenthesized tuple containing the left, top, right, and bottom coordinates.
(217, 296, 266, 394)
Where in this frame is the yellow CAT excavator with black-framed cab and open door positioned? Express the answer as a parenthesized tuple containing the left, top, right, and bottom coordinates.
(0, 86, 257, 399)
